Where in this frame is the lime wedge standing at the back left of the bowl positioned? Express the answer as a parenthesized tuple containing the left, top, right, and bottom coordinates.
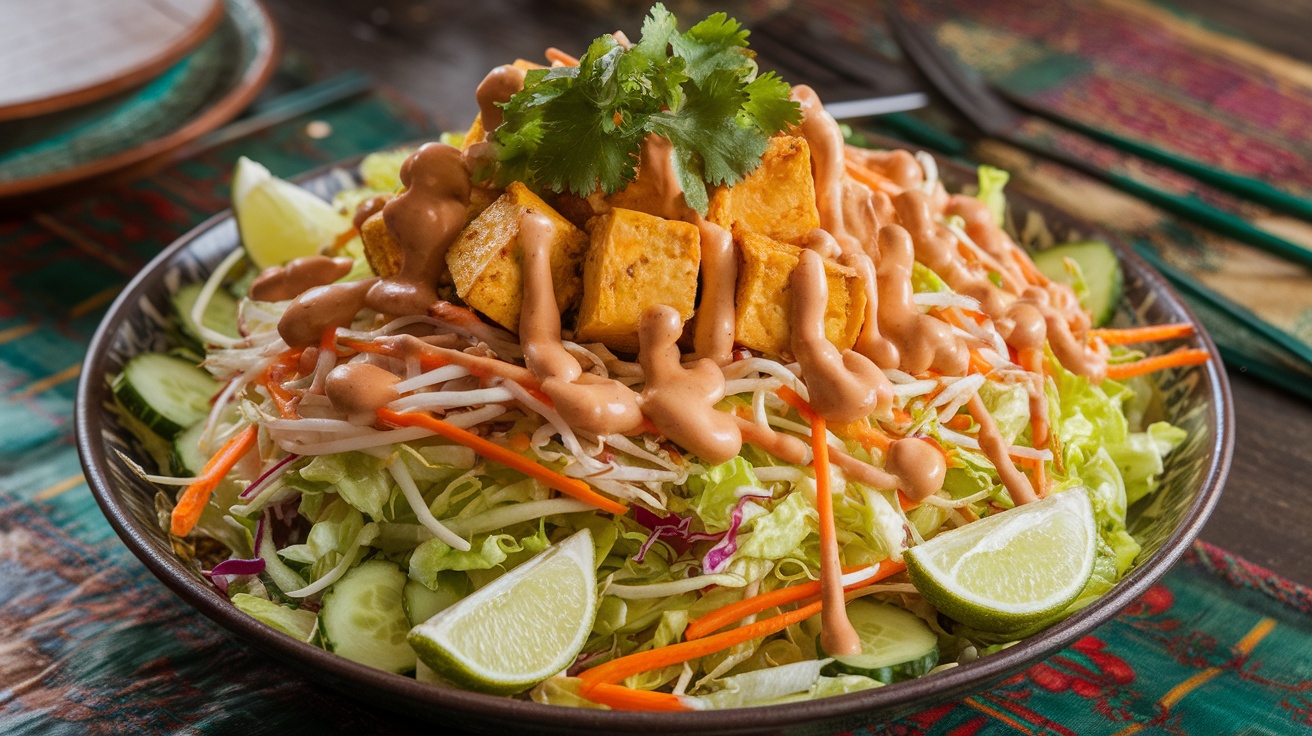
(232, 156, 350, 269)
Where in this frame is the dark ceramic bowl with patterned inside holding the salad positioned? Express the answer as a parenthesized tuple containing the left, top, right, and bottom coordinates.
(77, 153, 1233, 733)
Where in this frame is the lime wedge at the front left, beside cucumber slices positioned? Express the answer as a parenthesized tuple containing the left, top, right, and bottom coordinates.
(409, 529, 597, 695)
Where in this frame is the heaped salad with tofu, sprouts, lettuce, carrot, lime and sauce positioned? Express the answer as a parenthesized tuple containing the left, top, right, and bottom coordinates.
(113, 5, 1208, 710)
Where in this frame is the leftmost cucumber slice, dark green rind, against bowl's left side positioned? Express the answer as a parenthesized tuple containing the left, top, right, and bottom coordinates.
(113, 353, 219, 440)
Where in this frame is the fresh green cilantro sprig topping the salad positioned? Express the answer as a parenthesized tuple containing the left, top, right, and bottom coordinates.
(492, 3, 802, 214)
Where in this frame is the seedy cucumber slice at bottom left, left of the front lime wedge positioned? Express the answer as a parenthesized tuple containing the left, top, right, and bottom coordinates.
(319, 560, 416, 673)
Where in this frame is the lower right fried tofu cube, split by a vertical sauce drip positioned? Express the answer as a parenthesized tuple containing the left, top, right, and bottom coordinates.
(733, 224, 866, 357)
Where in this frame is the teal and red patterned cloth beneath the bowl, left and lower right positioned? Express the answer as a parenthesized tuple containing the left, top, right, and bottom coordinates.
(0, 96, 1312, 736)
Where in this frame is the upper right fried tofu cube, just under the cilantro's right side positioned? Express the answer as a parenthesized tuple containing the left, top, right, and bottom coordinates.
(707, 135, 820, 245)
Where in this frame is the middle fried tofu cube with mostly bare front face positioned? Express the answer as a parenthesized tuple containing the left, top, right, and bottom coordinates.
(575, 207, 702, 352)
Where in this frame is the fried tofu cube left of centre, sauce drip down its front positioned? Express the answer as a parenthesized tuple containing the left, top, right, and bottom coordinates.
(446, 181, 588, 332)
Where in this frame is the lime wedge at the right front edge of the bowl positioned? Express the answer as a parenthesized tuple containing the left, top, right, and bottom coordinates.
(905, 488, 1098, 632)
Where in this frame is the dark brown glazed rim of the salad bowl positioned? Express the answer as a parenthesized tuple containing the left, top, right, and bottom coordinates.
(75, 156, 1235, 733)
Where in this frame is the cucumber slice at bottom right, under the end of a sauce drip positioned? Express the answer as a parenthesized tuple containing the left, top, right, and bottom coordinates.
(817, 598, 938, 684)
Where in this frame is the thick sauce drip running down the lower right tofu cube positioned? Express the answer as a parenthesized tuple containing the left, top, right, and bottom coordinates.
(791, 251, 893, 422)
